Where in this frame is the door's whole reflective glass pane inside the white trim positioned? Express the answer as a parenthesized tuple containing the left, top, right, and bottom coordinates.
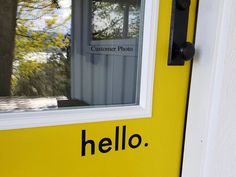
(0, 0, 143, 112)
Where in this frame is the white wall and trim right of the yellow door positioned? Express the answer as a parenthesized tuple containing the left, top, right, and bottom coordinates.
(182, 0, 236, 177)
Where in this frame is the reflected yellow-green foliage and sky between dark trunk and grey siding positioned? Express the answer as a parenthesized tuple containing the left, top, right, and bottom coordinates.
(12, 0, 71, 96)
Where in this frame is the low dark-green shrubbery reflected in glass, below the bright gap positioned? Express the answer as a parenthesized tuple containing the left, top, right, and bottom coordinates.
(13, 45, 70, 96)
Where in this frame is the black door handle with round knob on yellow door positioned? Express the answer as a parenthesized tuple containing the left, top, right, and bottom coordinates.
(168, 0, 195, 65)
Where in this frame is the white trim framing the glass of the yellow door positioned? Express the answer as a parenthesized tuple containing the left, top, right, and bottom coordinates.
(0, 0, 159, 130)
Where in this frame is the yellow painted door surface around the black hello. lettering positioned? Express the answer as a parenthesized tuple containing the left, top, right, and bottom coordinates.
(0, 0, 196, 177)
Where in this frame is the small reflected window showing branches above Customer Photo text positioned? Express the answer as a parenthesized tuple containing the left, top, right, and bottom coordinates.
(92, 0, 140, 40)
